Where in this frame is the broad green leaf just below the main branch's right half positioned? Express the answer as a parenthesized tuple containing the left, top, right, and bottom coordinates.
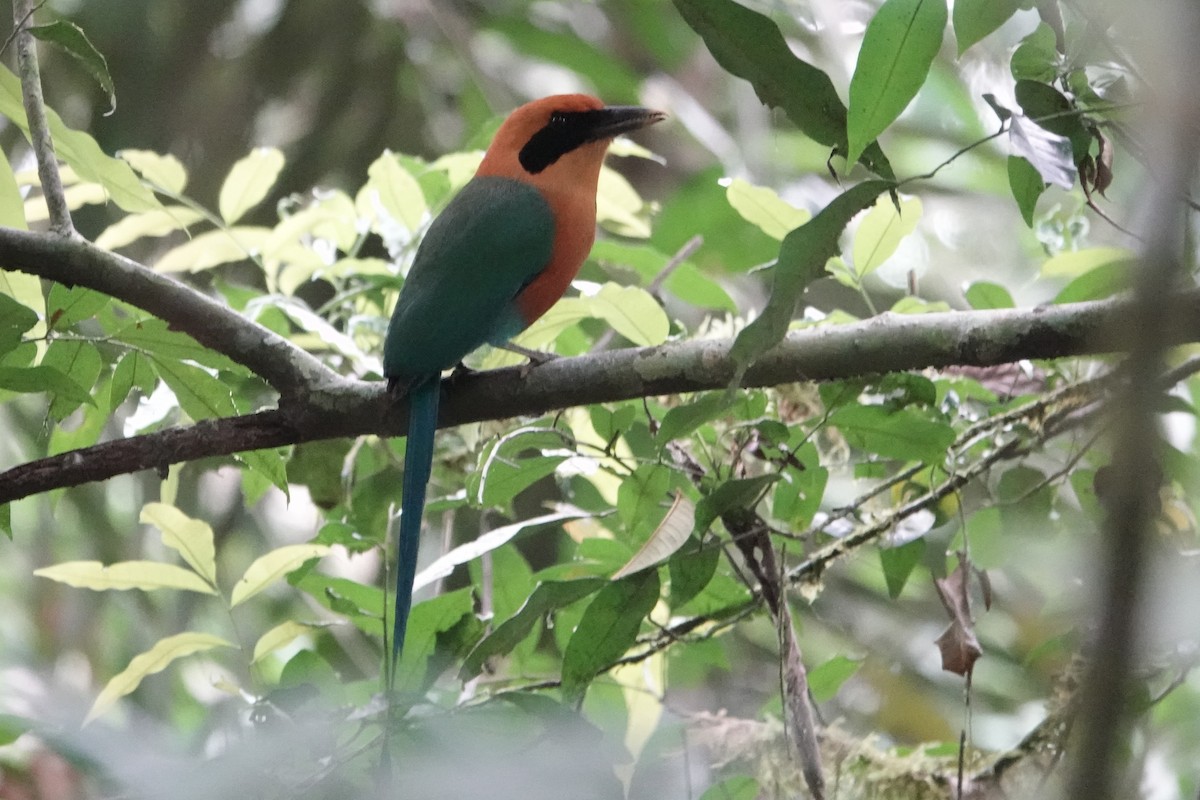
(829, 405, 955, 463)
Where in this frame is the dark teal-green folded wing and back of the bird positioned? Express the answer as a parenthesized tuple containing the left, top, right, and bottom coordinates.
(384, 178, 554, 383)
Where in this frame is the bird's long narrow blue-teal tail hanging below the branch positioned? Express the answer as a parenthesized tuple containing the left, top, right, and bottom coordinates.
(389, 375, 442, 685)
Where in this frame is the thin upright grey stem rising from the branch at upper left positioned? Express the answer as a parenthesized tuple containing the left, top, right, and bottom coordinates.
(12, 0, 74, 236)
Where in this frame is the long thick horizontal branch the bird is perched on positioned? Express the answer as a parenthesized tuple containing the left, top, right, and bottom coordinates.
(7, 289, 1200, 503)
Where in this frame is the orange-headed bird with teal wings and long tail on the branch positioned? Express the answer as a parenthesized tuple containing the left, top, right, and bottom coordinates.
(383, 94, 666, 680)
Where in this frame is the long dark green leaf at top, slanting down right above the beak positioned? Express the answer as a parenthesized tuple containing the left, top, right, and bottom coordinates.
(674, 0, 894, 179)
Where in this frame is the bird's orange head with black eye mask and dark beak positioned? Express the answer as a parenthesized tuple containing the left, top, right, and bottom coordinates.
(479, 95, 666, 193)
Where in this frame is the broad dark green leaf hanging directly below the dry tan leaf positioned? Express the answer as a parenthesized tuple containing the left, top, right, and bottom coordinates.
(563, 570, 660, 703)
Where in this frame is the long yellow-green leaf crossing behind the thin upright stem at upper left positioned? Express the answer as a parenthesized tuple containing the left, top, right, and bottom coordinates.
(0, 67, 158, 211)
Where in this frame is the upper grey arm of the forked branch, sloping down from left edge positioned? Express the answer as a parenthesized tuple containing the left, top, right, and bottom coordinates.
(0, 228, 346, 402)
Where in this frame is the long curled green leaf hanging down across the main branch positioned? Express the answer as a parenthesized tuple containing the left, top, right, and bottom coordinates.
(730, 181, 892, 376)
